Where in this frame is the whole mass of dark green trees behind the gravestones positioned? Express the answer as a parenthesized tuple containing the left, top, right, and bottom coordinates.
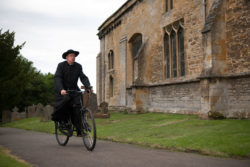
(0, 29, 54, 115)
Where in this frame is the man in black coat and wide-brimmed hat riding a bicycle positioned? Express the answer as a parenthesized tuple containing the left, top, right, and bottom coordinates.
(52, 49, 93, 136)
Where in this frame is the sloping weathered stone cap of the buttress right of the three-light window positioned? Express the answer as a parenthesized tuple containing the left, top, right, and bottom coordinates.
(202, 0, 223, 33)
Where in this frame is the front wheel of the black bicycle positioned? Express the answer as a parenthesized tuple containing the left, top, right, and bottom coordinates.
(82, 108, 96, 151)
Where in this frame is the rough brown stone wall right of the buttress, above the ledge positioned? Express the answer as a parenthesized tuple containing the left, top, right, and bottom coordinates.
(226, 0, 250, 73)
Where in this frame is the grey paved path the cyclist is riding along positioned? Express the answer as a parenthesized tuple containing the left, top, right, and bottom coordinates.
(0, 128, 250, 167)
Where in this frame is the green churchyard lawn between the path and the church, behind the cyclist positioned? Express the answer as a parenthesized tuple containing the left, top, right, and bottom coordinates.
(3, 113, 250, 158)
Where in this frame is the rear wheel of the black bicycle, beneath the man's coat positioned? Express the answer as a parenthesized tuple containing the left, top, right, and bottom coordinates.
(55, 122, 73, 146)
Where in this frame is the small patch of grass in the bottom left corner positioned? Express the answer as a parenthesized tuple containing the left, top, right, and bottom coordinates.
(0, 147, 30, 167)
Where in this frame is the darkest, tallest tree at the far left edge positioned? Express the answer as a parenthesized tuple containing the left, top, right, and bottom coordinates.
(0, 30, 27, 111)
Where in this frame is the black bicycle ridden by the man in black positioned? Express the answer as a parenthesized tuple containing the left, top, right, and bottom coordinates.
(55, 90, 96, 151)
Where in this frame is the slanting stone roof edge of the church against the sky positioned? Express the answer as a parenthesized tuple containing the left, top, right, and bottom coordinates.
(98, 0, 142, 31)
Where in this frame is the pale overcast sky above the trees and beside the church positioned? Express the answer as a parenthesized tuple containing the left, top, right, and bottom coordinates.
(0, 0, 127, 88)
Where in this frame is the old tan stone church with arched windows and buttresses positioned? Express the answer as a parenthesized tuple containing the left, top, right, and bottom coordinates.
(97, 0, 250, 118)
